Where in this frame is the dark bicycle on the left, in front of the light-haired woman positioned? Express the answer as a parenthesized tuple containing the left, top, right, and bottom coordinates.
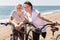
(0, 22, 31, 40)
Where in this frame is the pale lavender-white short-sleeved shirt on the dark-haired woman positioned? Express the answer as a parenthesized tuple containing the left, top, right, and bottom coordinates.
(27, 9, 46, 32)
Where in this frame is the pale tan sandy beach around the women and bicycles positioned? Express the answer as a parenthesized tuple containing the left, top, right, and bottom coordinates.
(0, 11, 60, 40)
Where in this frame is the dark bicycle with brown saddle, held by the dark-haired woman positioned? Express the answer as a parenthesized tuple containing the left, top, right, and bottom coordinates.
(23, 23, 60, 40)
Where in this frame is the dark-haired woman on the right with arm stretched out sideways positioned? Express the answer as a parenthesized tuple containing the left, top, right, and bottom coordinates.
(24, 1, 56, 40)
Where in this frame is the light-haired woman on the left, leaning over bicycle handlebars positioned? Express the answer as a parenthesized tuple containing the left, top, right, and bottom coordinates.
(10, 4, 25, 40)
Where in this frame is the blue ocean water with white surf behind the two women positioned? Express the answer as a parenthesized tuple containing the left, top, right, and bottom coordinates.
(0, 6, 60, 20)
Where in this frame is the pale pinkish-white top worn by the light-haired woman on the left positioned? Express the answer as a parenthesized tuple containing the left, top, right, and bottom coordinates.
(10, 10, 25, 23)
